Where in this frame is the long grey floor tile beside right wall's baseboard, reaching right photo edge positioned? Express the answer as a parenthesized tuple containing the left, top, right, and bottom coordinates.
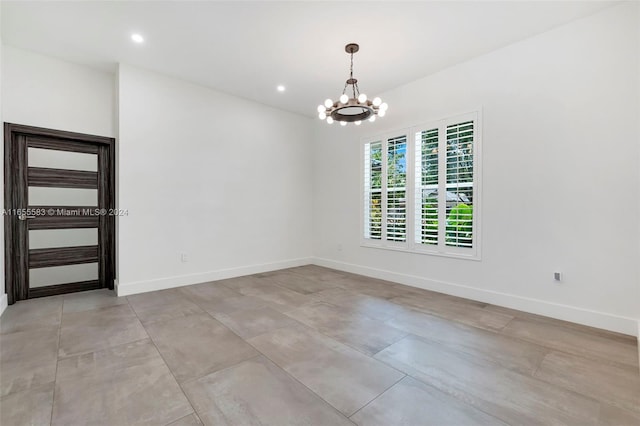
(503, 318, 638, 367)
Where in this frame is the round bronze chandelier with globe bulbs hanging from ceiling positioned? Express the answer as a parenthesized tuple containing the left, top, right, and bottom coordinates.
(318, 43, 387, 126)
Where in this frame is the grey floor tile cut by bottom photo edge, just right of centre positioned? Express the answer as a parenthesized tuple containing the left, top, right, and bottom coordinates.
(351, 377, 506, 426)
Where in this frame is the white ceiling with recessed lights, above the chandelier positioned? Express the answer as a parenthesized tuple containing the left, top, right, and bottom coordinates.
(1, 0, 616, 117)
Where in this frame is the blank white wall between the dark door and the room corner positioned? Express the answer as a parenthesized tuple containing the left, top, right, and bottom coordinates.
(118, 65, 312, 295)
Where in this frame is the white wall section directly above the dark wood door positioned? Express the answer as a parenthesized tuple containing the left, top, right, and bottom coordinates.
(2, 46, 115, 137)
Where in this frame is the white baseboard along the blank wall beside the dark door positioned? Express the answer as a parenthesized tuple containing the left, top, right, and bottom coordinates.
(116, 257, 311, 296)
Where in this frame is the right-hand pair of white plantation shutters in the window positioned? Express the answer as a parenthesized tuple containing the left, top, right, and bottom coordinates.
(412, 113, 478, 257)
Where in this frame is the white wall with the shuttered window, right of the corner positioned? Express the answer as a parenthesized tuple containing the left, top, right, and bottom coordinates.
(313, 3, 640, 334)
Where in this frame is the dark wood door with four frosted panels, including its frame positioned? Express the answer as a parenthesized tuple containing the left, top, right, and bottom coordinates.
(4, 123, 116, 304)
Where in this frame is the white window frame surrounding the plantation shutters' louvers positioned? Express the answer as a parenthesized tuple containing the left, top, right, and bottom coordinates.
(360, 108, 482, 260)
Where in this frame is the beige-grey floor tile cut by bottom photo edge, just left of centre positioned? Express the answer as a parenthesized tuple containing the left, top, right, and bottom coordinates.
(184, 356, 352, 426)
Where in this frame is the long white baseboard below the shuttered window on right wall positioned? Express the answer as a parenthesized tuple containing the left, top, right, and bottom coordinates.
(312, 257, 640, 343)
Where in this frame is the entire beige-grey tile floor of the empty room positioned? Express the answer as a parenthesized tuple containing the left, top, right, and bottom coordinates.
(0, 266, 640, 426)
